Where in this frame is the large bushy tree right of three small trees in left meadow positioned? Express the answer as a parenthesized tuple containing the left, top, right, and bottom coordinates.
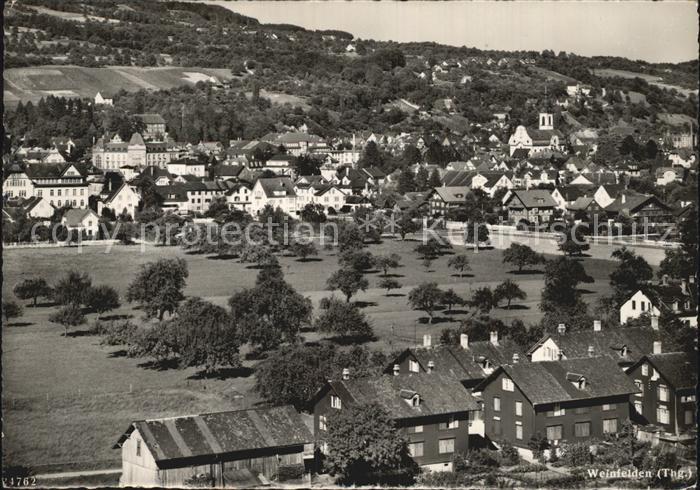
(126, 258, 188, 320)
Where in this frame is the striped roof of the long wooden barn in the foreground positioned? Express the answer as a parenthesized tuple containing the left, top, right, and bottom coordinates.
(114, 405, 313, 467)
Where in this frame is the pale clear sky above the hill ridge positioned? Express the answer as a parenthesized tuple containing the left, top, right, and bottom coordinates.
(206, 0, 698, 63)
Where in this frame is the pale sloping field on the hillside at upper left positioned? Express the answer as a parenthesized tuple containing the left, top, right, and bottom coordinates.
(3, 65, 237, 105)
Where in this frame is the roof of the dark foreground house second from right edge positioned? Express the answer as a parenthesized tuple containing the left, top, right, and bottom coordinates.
(476, 357, 639, 405)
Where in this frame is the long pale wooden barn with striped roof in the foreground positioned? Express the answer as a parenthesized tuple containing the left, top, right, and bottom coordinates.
(113, 406, 313, 488)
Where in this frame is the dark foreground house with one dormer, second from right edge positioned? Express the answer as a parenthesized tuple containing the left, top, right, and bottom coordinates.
(475, 357, 638, 450)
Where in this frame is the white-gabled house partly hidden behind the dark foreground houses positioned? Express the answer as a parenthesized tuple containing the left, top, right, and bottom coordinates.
(527, 320, 658, 367)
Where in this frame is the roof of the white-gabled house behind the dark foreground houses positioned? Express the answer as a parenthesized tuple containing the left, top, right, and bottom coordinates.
(528, 328, 655, 363)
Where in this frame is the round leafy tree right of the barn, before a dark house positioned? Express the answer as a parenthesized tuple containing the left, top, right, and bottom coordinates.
(325, 403, 417, 485)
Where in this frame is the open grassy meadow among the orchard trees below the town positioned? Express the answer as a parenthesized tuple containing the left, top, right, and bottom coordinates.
(2, 240, 610, 472)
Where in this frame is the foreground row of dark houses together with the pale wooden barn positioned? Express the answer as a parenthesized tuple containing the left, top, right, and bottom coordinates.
(114, 322, 697, 487)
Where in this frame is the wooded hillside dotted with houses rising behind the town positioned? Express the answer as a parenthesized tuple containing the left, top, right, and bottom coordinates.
(4, 0, 698, 151)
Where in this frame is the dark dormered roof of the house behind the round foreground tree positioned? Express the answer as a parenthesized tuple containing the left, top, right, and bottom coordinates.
(329, 372, 478, 420)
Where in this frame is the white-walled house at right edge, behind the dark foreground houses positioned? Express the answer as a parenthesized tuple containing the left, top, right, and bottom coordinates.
(620, 275, 698, 327)
